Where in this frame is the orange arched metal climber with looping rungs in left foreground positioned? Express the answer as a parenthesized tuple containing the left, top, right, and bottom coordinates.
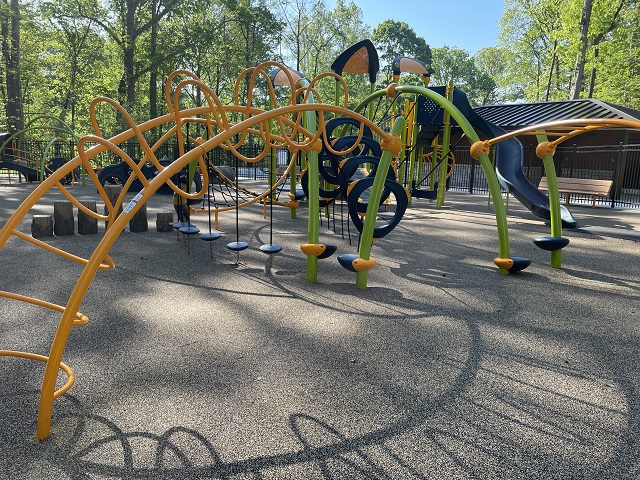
(0, 62, 399, 439)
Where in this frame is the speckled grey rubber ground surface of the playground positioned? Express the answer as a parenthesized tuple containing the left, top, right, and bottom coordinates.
(0, 184, 640, 480)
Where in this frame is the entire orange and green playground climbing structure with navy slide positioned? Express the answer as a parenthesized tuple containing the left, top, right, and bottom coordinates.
(0, 38, 640, 439)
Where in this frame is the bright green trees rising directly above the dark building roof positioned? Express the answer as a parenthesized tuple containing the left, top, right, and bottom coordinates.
(495, 0, 640, 108)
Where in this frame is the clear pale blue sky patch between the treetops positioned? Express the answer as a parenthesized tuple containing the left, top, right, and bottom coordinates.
(327, 0, 504, 55)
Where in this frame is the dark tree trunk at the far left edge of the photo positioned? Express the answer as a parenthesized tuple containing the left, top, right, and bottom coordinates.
(2, 0, 24, 134)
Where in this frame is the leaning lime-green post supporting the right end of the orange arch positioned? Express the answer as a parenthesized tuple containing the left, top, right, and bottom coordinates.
(356, 117, 407, 288)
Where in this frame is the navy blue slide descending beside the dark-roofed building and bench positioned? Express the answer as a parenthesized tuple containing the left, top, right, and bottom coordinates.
(432, 87, 578, 228)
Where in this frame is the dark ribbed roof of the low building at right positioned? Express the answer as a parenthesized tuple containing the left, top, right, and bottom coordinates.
(474, 98, 640, 130)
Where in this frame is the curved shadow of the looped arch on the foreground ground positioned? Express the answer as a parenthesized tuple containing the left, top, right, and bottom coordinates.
(41, 308, 481, 479)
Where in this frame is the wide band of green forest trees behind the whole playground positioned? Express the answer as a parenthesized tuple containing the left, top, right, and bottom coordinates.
(0, 0, 640, 136)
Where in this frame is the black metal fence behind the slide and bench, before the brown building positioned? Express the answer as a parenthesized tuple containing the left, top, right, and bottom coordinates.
(449, 144, 640, 208)
